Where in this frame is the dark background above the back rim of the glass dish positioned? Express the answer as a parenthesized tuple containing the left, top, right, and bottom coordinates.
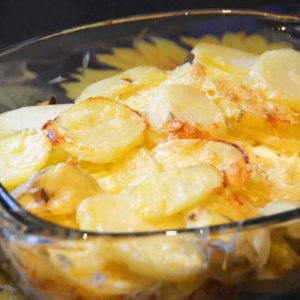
(0, 0, 300, 48)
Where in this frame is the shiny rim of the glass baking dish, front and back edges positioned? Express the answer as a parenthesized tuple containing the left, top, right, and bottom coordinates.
(0, 9, 300, 239)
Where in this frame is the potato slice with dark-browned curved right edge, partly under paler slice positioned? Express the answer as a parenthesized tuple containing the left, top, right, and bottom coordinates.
(152, 139, 251, 187)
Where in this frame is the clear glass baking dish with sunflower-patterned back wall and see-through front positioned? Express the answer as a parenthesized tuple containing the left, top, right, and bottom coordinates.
(0, 10, 300, 300)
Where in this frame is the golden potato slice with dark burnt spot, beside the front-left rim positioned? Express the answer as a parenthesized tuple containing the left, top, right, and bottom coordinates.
(13, 163, 101, 219)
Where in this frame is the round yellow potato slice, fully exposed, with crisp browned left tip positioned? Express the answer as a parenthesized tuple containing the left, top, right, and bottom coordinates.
(45, 98, 146, 163)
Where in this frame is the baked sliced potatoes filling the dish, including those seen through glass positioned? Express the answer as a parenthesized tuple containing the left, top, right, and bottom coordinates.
(0, 43, 300, 299)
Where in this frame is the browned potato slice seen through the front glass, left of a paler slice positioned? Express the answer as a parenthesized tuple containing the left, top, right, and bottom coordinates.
(48, 240, 151, 299)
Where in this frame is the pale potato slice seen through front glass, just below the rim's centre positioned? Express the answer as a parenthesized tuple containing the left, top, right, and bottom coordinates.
(115, 236, 202, 281)
